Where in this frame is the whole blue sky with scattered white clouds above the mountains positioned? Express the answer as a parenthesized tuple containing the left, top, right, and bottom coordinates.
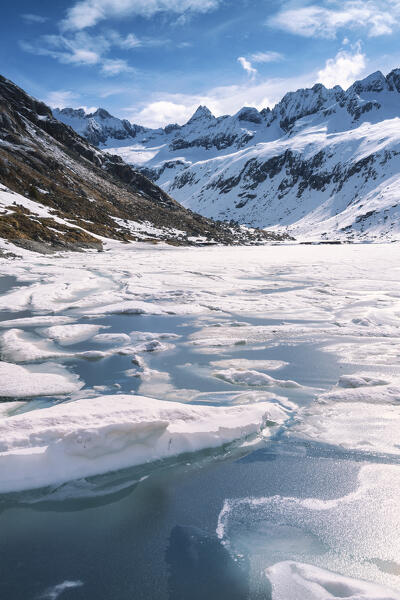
(0, 0, 400, 126)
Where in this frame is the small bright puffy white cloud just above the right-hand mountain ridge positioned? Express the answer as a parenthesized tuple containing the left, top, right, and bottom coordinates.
(318, 44, 366, 89)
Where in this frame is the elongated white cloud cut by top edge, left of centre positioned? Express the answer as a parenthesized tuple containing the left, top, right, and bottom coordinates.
(63, 0, 220, 30)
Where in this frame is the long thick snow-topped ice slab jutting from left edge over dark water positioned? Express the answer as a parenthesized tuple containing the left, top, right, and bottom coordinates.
(0, 395, 276, 492)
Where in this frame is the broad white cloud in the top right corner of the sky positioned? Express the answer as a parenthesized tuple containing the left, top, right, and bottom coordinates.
(267, 0, 400, 39)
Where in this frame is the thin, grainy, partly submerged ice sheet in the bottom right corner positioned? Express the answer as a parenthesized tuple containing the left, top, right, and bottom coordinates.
(217, 464, 400, 600)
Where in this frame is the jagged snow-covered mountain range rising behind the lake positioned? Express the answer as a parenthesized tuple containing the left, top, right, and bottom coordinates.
(54, 69, 400, 239)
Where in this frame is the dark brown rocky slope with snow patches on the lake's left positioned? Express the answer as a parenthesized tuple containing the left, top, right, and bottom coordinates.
(0, 76, 282, 250)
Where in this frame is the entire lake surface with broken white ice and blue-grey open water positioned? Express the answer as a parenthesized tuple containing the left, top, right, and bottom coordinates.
(0, 244, 400, 600)
